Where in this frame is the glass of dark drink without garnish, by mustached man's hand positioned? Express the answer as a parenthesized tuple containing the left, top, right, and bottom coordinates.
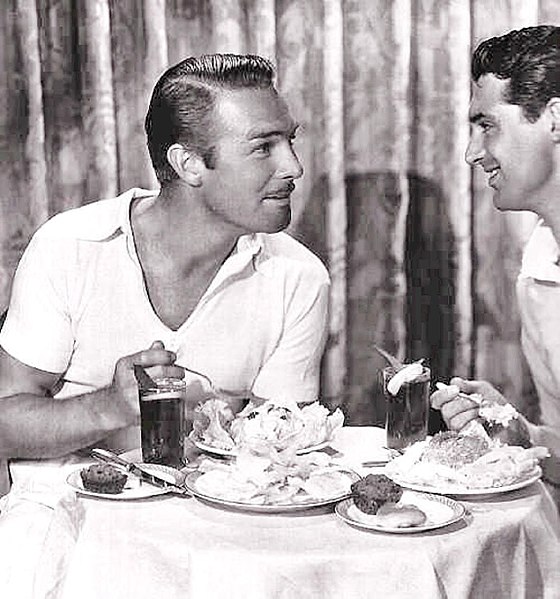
(140, 379, 186, 468)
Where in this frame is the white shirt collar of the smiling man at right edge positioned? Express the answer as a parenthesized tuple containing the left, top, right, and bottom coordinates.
(519, 219, 560, 283)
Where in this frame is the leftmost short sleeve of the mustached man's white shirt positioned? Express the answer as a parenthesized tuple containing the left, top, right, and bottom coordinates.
(0, 229, 73, 373)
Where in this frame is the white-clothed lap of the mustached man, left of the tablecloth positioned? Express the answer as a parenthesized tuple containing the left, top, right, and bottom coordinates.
(0, 481, 84, 599)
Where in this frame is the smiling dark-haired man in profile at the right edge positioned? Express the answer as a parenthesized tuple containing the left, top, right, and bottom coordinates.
(432, 26, 560, 496)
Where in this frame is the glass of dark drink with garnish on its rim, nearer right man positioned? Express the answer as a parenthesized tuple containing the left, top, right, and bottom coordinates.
(382, 366, 430, 449)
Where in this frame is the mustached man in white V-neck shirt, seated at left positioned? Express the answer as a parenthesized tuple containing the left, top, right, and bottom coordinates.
(0, 55, 329, 492)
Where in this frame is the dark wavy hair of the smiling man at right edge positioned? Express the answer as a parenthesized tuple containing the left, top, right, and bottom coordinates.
(471, 25, 560, 123)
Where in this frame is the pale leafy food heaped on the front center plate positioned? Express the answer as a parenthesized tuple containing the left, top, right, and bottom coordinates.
(195, 448, 356, 506)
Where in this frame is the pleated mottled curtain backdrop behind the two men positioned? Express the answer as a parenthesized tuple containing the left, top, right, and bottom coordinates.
(0, 0, 560, 424)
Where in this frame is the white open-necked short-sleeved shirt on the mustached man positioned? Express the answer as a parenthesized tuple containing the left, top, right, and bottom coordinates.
(0, 189, 329, 450)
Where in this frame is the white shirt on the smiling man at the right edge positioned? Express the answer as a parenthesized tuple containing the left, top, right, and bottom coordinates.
(517, 221, 560, 484)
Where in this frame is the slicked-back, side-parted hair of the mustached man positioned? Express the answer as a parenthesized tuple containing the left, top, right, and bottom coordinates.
(144, 54, 274, 185)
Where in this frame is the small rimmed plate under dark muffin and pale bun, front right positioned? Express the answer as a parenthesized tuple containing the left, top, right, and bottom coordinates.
(335, 491, 465, 534)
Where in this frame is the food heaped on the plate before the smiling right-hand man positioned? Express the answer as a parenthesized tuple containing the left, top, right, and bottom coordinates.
(385, 427, 549, 490)
